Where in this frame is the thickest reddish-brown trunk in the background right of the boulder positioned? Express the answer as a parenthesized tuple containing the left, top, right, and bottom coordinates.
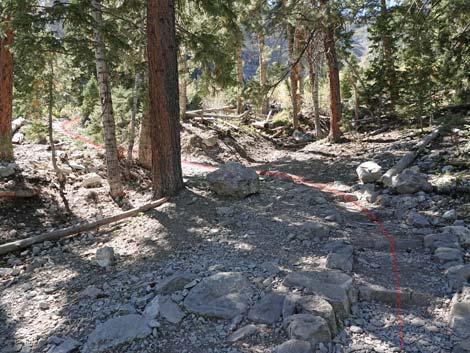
(320, 0, 342, 142)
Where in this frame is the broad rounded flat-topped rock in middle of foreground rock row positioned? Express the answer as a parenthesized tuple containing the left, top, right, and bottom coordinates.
(184, 272, 252, 319)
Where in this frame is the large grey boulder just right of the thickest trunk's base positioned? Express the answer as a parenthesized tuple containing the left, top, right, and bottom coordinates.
(207, 162, 260, 198)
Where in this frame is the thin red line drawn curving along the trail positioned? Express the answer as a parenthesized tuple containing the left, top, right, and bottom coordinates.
(60, 119, 404, 349)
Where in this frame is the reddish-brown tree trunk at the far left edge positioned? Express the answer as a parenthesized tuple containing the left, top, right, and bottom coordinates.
(0, 24, 13, 161)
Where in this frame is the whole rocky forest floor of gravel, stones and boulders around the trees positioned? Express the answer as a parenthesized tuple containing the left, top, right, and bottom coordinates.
(0, 119, 470, 353)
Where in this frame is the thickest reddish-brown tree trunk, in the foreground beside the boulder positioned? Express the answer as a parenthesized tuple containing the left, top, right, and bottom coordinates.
(147, 0, 183, 198)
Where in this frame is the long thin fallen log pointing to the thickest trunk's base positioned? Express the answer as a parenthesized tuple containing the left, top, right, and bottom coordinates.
(0, 197, 168, 255)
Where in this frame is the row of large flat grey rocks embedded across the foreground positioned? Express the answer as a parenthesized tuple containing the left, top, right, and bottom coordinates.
(76, 269, 357, 353)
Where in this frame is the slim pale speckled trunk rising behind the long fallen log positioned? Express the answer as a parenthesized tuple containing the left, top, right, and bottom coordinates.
(91, 0, 124, 198)
